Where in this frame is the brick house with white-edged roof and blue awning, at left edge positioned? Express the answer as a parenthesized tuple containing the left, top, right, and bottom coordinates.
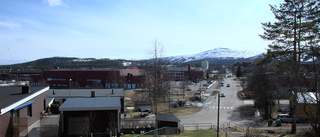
(0, 86, 49, 137)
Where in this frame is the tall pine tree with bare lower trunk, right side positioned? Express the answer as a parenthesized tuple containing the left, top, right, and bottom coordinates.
(260, 0, 318, 134)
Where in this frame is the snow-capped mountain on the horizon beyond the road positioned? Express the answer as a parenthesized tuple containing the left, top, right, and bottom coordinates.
(164, 48, 262, 63)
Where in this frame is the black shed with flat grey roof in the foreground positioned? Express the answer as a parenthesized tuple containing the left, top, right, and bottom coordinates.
(59, 97, 121, 136)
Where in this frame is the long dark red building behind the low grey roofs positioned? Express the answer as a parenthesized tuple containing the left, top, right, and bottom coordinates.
(30, 69, 145, 89)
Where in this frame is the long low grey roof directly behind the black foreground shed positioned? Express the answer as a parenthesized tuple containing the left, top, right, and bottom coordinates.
(47, 88, 124, 99)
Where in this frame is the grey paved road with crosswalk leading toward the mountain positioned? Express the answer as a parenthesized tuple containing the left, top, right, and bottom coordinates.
(179, 78, 248, 130)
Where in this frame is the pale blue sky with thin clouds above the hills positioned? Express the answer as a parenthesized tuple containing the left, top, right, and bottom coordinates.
(0, 0, 283, 65)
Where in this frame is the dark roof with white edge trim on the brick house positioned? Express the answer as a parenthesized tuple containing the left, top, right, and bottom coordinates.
(0, 86, 49, 115)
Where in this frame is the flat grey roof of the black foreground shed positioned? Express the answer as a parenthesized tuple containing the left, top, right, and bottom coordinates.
(59, 97, 121, 111)
